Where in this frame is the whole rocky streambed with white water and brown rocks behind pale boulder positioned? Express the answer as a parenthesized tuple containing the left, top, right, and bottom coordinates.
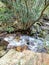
(0, 34, 49, 57)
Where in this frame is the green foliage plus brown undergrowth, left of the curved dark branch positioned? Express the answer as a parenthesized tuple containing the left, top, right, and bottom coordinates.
(0, 0, 49, 32)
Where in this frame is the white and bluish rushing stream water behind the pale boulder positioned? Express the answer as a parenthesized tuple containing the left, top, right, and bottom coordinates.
(4, 35, 47, 52)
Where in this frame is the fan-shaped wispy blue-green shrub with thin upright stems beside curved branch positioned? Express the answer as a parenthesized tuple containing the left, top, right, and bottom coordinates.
(1, 0, 45, 22)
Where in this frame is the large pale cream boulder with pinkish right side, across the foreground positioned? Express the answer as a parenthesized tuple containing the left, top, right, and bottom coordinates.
(0, 49, 49, 65)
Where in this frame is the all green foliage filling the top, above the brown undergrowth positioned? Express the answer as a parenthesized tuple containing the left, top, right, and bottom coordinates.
(0, 0, 48, 32)
